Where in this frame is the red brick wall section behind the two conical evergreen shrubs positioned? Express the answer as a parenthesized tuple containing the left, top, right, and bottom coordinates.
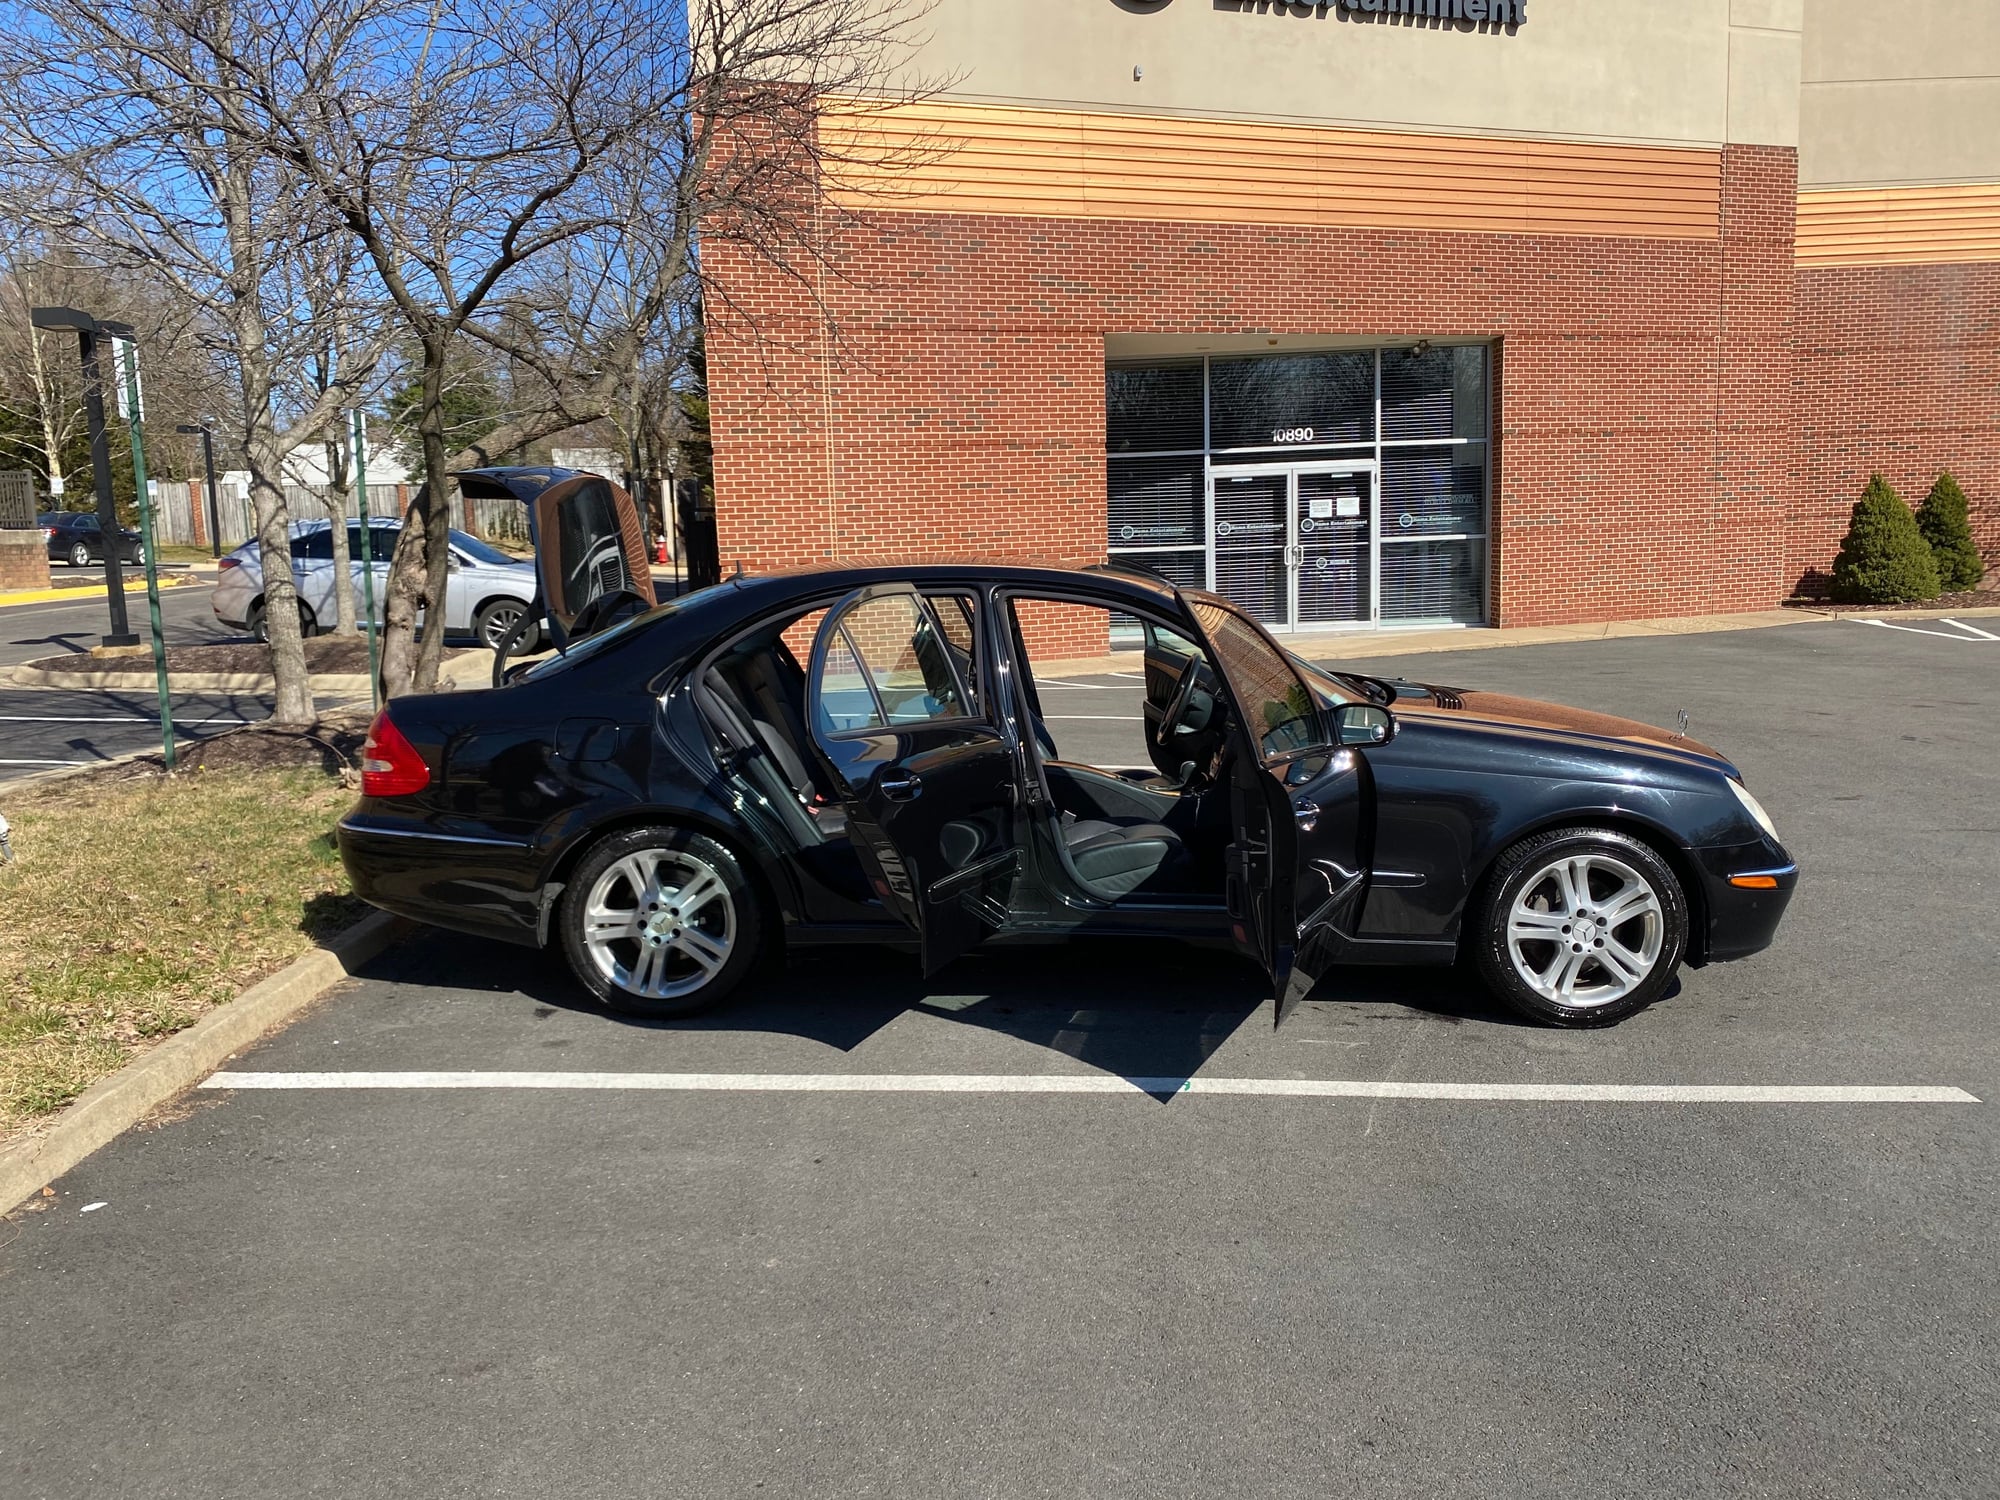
(1788, 262, 2000, 594)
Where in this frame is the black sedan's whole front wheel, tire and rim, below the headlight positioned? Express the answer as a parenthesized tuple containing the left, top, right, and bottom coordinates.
(1470, 828, 1688, 1026)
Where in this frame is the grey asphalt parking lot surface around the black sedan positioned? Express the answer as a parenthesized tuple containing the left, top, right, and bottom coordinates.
(0, 622, 2000, 1496)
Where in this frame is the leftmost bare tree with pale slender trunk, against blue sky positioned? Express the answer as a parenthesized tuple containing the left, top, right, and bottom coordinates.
(0, 0, 390, 724)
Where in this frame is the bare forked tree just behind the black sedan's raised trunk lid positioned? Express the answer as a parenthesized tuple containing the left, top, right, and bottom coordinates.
(238, 0, 928, 694)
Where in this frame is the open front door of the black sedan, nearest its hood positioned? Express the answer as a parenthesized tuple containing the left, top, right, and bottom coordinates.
(1182, 592, 1388, 1022)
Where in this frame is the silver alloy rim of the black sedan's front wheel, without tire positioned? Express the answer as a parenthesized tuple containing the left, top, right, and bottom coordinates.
(1506, 854, 1666, 1010)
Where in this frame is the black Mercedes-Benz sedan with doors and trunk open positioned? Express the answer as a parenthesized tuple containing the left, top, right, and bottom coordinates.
(340, 472, 1798, 1026)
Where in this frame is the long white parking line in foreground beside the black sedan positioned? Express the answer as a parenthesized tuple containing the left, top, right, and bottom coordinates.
(202, 1070, 1980, 1104)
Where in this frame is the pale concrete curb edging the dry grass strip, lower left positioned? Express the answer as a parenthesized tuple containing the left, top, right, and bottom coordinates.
(0, 912, 408, 1214)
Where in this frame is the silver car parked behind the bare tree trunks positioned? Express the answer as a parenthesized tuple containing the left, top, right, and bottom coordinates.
(214, 520, 542, 652)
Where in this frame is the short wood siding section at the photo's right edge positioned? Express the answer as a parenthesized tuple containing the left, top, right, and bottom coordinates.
(1798, 182, 2000, 266)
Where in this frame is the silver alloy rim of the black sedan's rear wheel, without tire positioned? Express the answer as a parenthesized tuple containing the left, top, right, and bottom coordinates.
(582, 848, 736, 1000)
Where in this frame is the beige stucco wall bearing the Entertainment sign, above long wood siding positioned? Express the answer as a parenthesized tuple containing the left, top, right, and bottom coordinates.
(900, 0, 1808, 146)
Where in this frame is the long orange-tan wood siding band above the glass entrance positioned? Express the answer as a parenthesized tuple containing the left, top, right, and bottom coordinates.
(820, 102, 1722, 240)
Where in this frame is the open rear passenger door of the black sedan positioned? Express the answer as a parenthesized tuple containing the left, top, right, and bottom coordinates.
(808, 584, 1020, 974)
